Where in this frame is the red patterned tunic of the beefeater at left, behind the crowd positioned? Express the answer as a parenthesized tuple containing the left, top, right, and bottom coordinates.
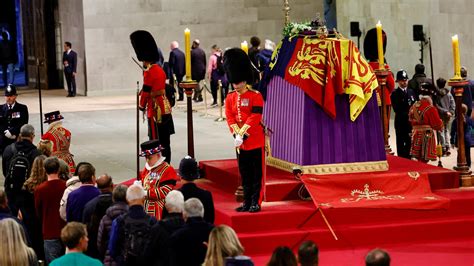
(41, 123, 76, 174)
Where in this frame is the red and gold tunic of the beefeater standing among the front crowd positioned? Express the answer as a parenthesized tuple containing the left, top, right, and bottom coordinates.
(140, 162, 179, 220)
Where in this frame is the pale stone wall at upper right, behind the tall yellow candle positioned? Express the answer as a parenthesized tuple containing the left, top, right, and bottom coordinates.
(337, 0, 474, 82)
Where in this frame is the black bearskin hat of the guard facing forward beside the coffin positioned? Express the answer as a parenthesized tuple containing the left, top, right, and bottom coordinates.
(224, 48, 253, 84)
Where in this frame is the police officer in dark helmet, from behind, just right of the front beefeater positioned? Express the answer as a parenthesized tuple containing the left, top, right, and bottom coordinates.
(171, 156, 214, 224)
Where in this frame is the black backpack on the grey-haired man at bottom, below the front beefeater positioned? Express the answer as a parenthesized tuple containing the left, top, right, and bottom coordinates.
(122, 214, 154, 265)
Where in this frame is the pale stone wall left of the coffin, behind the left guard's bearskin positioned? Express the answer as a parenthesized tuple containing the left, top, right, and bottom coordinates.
(79, 0, 323, 95)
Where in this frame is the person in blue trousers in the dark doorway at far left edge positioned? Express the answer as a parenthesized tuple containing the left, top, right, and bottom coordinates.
(0, 31, 18, 87)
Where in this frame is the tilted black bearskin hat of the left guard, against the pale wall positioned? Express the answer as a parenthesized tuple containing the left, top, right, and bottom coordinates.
(130, 30, 160, 62)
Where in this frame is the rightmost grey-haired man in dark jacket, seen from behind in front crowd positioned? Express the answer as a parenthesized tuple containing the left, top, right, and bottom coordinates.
(169, 198, 214, 266)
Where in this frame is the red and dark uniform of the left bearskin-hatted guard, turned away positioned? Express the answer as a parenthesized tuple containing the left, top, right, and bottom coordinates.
(139, 64, 174, 163)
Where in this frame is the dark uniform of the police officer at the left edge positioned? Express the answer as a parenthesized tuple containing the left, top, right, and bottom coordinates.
(0, 102, 29, 154)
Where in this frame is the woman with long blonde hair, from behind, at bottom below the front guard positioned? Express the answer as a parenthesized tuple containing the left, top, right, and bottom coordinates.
(203, 225, 254, 266)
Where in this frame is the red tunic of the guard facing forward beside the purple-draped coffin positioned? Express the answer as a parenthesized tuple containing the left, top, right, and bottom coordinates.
(225, 89, 265, 150)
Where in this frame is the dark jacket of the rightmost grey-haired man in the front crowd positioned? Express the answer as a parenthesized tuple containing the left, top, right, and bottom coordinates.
(169, 217, 214, 266)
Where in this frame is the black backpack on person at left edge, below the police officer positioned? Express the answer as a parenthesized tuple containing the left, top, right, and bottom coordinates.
(5, 144, 30, 192)
